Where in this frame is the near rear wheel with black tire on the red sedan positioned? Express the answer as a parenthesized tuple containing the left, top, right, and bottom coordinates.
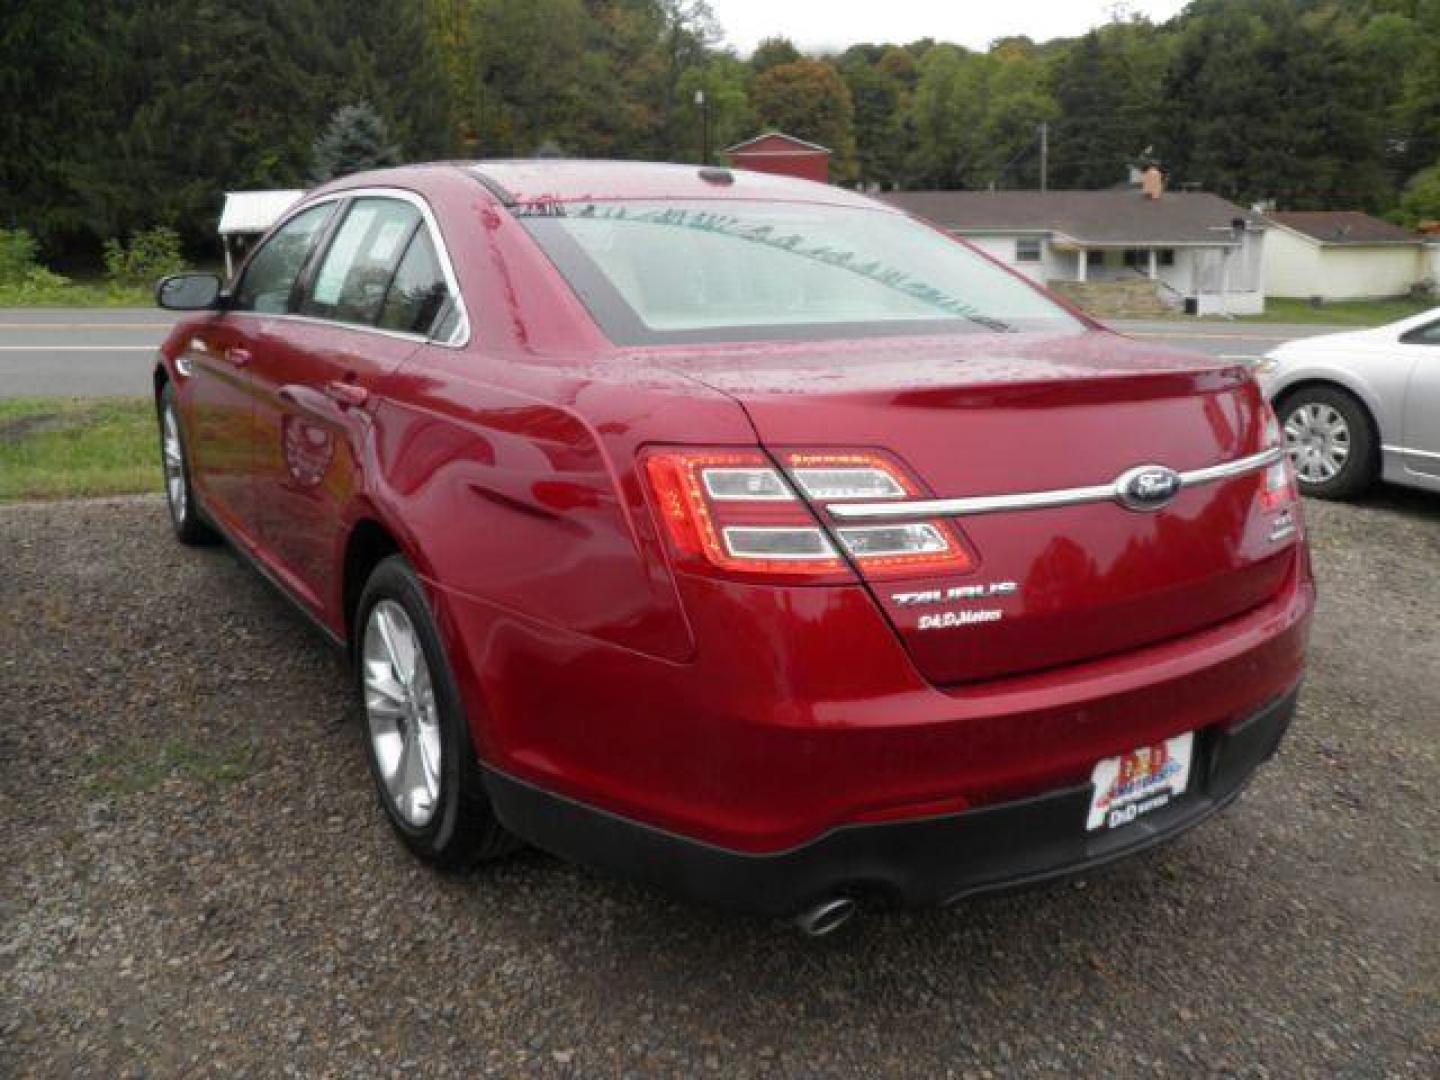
(354, 556, 518, 870)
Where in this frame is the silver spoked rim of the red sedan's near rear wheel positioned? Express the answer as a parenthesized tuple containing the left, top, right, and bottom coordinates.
(361, 600, 441, 828)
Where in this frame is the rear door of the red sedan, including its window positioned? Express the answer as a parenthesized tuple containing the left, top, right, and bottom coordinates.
(241, 194, 449, 618)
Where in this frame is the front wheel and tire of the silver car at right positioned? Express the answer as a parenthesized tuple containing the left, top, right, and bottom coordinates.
(1276, 386, 1380, 500)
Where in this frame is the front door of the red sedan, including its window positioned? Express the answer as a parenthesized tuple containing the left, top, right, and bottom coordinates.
(179, 206, 334, 546)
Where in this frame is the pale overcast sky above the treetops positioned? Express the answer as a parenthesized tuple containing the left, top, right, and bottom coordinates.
(710, 0, 1185, 56)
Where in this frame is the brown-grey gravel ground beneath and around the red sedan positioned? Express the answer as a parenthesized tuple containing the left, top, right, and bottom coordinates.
(0, 491, 1440, 1077)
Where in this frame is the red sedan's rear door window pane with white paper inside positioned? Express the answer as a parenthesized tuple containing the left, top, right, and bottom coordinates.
(300, 199, 423, 325)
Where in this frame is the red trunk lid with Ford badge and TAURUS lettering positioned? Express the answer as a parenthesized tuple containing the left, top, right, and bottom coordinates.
(651, 331, 1293, 684)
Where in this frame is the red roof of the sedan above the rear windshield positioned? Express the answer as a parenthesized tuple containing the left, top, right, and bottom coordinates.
(464, 158, 893, 213)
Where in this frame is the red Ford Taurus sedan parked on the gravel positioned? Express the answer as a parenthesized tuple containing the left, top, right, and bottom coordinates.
(156, 161, 1315, 932)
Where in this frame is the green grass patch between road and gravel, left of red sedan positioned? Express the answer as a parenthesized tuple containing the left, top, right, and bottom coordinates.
(0, 397, 161, 503)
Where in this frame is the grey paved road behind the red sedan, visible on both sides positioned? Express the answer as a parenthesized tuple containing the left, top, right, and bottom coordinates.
(0, 308, 1339, 397)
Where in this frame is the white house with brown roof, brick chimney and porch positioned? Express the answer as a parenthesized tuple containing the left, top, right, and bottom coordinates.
(880, 187, 1266, 315)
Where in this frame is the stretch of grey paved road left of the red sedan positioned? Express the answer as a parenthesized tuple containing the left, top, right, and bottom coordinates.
(0, 308, 176, 397)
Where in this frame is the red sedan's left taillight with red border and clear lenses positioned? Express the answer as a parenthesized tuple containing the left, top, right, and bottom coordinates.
(644, 449, 975, 583)
